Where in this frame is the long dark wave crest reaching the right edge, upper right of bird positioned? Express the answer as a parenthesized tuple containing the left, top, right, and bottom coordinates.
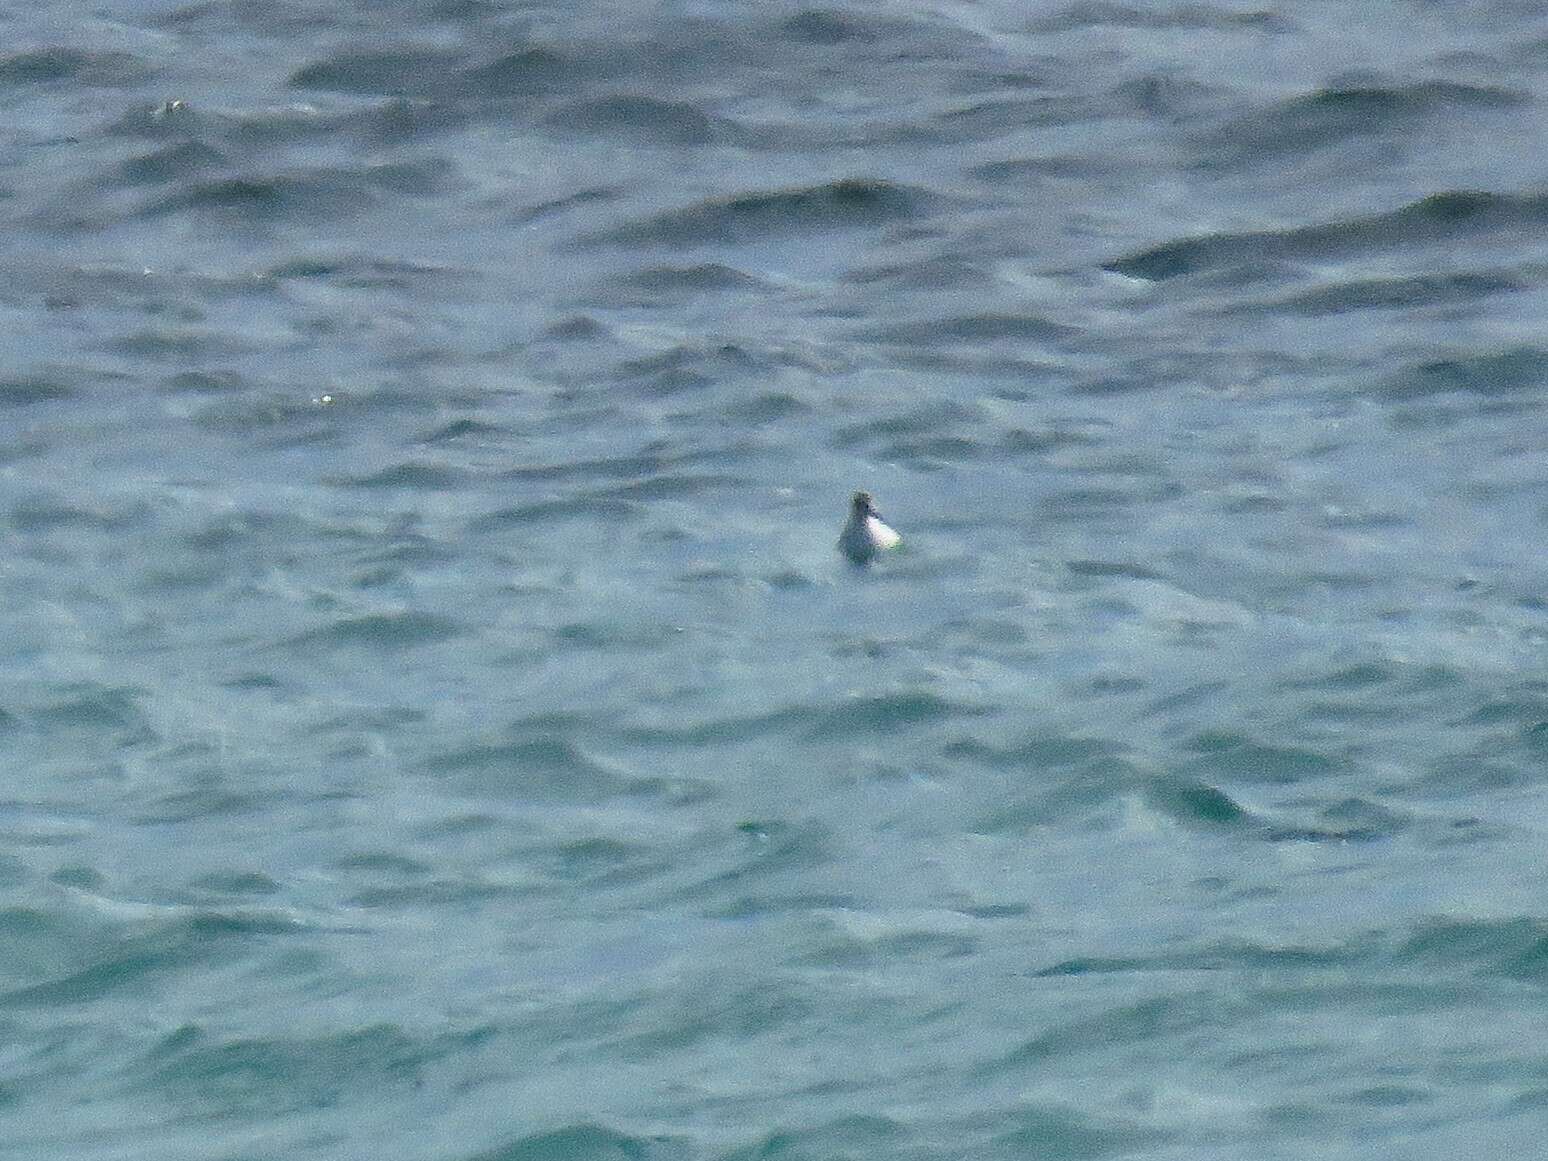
(1102, 190, 1548, 282)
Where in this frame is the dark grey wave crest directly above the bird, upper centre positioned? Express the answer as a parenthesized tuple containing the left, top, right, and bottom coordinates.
(582, 178, 935, 246)
